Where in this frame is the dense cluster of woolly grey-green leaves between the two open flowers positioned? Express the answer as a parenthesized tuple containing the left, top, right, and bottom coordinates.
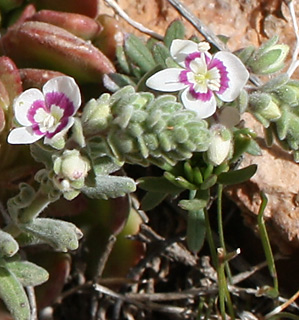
(82, 86, 210, 170)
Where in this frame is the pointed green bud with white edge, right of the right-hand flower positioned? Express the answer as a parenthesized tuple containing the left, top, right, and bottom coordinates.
(248, 37, 289, 74)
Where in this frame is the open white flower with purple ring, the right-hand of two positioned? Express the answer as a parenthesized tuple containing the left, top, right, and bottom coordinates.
(146, 39, 249, 118)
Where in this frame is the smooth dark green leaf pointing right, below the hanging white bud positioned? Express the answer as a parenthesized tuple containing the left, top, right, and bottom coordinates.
(217, 164, 257, 185)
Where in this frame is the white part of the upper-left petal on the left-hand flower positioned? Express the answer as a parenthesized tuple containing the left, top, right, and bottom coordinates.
(13, 89, 44, 126)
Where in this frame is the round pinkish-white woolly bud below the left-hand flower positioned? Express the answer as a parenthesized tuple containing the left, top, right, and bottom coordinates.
(52, 150, 90, 200)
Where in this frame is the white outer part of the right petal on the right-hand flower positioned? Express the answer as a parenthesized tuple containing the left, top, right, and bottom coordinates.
(214, 51, 249, 102)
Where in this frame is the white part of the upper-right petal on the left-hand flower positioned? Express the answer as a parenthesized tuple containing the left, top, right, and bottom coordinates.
(43, 76, 81, 112)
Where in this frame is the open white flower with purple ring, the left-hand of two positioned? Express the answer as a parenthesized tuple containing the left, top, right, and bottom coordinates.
(7, 76, 81, 144)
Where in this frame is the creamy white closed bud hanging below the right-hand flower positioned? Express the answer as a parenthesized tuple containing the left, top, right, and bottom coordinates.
(207, 124, 232, 166)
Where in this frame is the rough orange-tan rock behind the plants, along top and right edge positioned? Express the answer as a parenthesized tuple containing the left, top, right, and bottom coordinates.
(101, 0, 299, 252)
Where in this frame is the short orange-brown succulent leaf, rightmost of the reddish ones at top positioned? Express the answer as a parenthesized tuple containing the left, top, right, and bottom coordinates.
(93, 14, 123, 60)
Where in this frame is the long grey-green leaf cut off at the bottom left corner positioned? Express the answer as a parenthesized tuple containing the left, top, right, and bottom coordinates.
(0, 267, 31, 320)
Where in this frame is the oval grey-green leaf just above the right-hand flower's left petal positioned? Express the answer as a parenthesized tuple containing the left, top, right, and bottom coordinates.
(124, 34, 156, 74)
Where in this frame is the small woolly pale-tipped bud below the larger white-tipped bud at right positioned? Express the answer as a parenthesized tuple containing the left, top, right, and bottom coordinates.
(249, 92, 281, 127)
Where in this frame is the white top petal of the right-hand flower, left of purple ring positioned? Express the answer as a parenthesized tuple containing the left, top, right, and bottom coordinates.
(170, 39, 198, 67)
